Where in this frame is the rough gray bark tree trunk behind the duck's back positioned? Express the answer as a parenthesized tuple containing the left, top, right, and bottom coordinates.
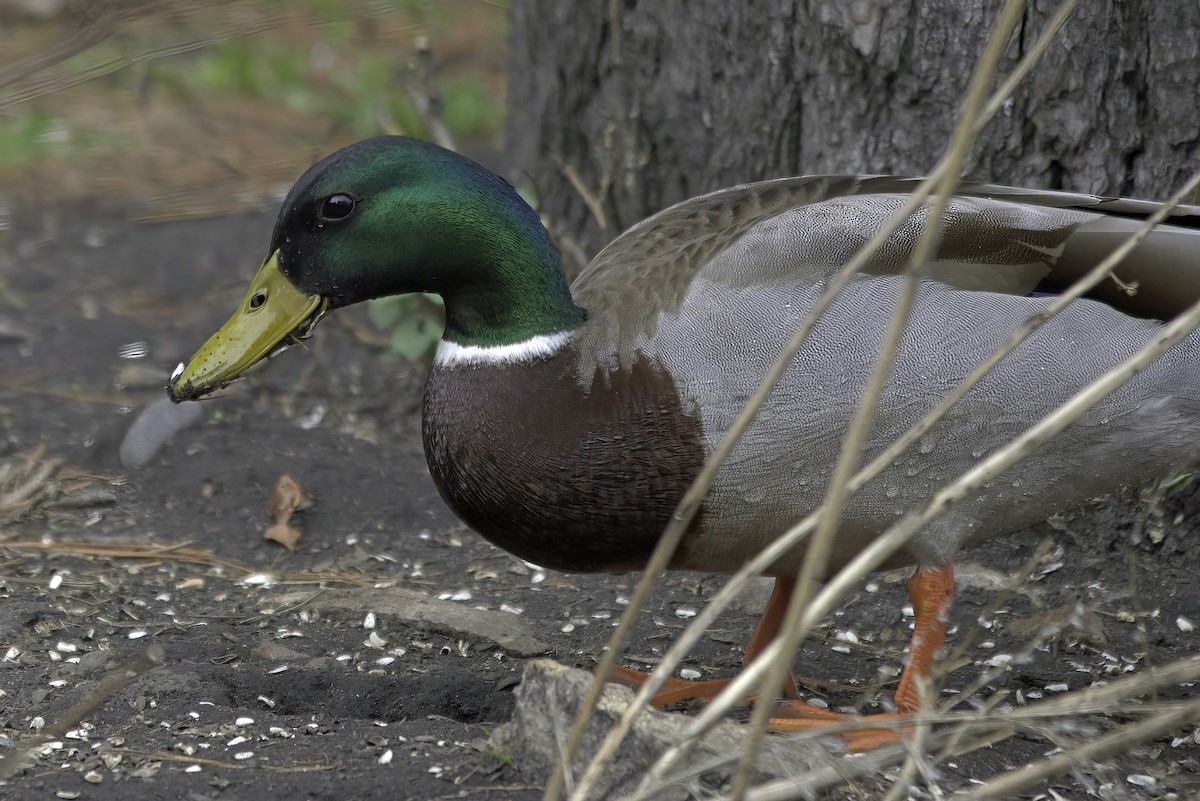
(508, 0, 1200, 269)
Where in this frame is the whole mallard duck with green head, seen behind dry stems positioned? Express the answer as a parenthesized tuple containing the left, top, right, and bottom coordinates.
(168, 137, 1200, 745)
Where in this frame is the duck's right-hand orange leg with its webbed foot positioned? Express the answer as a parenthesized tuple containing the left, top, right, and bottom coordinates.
(770, 565, 954, 751)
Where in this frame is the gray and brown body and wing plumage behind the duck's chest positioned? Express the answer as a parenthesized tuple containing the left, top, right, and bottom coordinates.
(574, 179, 1200, 573)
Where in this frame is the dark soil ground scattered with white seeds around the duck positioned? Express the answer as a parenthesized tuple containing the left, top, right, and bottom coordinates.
(0, 201, 1200, 801)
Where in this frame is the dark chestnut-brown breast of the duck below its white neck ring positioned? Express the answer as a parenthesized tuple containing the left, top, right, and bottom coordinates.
(422, 348, 704, 572)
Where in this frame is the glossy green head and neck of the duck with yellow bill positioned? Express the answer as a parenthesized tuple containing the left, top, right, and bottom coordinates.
(167, 137, 583, 402)
